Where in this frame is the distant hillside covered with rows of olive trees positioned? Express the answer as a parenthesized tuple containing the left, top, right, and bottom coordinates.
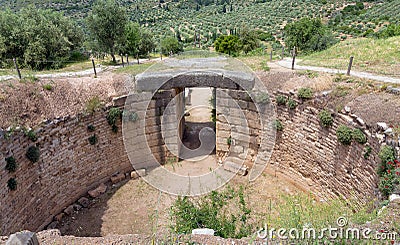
(0, 0, 400, 45)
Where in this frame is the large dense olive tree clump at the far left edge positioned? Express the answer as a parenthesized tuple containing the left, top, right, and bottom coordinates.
(0, 5, 83, 70)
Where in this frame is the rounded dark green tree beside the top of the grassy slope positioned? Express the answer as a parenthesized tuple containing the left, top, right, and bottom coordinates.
(284, 18, 337, 52)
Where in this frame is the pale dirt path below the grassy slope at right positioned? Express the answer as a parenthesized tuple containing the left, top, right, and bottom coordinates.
(276, 58, 400, 84)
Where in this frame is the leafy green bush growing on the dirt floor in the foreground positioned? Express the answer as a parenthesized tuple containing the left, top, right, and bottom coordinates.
(171, 187, 255, 239)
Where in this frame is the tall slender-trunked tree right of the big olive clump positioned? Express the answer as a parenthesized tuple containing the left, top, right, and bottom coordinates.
(86, 0, 128, 63)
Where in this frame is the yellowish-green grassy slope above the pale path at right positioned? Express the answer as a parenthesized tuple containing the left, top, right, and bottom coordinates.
(299, 37, 400, 77)
